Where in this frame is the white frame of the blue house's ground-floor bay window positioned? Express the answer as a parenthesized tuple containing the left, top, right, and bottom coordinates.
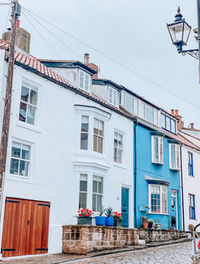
(149, 184, 168, 215)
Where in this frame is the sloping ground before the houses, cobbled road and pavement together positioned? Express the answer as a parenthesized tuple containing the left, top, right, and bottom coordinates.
(1, 239, 195, 264)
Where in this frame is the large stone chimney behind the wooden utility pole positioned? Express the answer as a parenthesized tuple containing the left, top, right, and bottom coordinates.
(2, 19, 31, 53)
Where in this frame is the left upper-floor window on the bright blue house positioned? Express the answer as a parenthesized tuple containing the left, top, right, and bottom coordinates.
(151, 136, 163, 164)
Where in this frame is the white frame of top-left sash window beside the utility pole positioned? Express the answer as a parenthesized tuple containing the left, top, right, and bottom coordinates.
(18, 78, 40, 127)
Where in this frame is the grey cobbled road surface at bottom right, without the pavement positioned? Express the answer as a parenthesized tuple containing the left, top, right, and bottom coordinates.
(68, 242, 192, 264)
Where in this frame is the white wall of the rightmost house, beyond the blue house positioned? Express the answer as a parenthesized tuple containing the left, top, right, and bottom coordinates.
(182, 145, 200, 230)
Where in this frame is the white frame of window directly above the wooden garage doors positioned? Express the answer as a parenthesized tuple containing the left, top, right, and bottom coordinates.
(8, 138, 33, 180)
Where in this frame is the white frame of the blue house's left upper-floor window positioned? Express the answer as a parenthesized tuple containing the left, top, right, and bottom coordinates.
(151, 135, 163, 165)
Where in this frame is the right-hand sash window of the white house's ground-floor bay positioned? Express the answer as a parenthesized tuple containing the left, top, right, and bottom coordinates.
(92, 176, 103, 212)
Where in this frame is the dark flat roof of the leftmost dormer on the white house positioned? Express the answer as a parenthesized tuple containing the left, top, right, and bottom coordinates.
(39, 59, 97, 74)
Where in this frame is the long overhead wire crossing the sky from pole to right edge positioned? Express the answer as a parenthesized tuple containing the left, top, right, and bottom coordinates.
(22, 7, 200, 109)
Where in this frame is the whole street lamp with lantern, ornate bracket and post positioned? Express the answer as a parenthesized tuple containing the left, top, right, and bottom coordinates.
(167, 0, 200, 82)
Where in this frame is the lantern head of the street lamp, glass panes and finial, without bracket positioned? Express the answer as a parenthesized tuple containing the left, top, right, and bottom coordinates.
(167, 7, 191, 53)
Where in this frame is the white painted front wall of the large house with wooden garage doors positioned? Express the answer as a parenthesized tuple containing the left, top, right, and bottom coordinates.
(1, 66, 133, 253)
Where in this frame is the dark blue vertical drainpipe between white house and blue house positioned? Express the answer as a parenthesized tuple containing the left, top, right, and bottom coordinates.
(133, 121, 138, 227)
